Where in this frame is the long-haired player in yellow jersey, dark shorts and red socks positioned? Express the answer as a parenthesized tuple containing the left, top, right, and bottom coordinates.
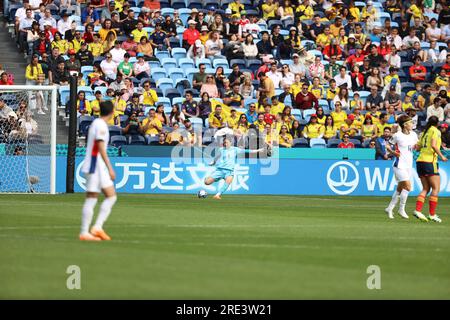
(414, 116, 447, 222)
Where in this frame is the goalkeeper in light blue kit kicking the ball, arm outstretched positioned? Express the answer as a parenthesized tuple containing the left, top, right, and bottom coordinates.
(205, 136, 264, 199)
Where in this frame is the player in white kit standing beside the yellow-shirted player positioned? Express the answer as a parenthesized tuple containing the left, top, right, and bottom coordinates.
(386, 115, 418, 219)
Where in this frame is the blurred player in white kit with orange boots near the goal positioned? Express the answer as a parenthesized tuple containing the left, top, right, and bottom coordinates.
(80, 101, 117, 241)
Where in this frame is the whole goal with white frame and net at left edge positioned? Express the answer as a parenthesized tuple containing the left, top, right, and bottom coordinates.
(0, 85, 58, 194)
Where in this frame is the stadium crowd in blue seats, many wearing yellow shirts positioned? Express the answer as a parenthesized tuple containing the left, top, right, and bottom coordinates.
(1, 0, 450, 152)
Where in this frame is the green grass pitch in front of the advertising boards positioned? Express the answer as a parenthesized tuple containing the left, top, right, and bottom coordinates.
(0, 194, 450, 299)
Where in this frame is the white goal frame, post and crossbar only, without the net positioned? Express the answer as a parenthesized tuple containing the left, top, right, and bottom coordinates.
(0, 85, 58, 194)
